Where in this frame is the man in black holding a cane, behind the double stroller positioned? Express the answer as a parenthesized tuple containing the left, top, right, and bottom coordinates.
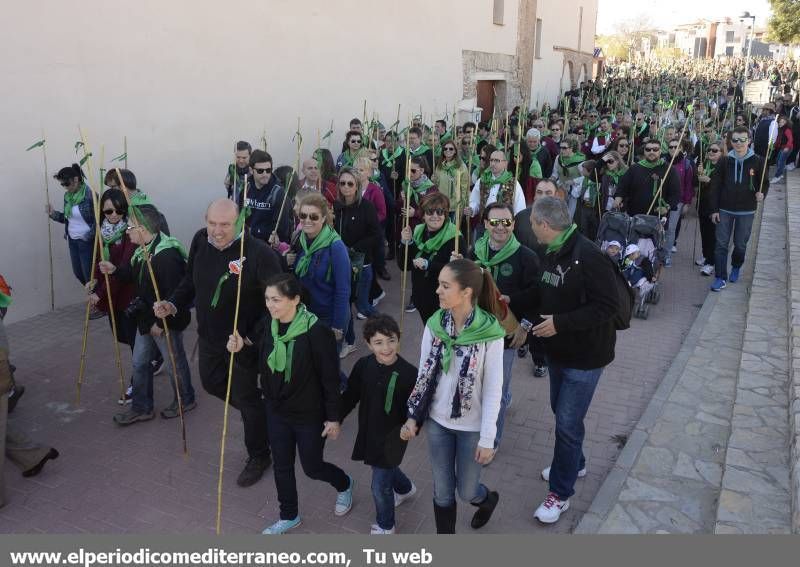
(614, 138, 680, 216)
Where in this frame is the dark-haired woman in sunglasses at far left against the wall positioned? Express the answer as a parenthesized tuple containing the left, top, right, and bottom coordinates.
(45, 163, 96, 288)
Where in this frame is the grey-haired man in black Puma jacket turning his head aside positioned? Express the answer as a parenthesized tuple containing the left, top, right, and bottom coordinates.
(511, 197, 619, 524)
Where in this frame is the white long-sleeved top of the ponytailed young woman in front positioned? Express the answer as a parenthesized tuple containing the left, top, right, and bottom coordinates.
(419, 325, 503, 449)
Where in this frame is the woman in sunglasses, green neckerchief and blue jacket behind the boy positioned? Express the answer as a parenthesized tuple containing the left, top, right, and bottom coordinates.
(286, 193, 351, 346)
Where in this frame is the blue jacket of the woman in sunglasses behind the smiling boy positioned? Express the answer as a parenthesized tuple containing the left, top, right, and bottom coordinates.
(294, 240, 351, 332)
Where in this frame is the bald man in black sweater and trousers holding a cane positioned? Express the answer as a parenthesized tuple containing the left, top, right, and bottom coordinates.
(153, 199, 281, 486)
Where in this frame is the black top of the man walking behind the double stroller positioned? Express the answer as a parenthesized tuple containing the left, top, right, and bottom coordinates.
(615, 161, 681, 216)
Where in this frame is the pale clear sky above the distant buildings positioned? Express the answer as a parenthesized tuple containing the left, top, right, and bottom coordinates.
(597, 0, 770, 34)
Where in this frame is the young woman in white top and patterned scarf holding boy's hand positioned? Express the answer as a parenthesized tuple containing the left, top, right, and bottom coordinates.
(400, 259, 505, 533)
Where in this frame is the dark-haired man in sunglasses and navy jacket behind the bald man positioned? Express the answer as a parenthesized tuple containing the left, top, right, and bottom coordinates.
(238, 150, 292, 246)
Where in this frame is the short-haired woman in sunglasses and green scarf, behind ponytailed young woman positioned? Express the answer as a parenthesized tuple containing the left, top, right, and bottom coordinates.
(397, 192, 464, 323)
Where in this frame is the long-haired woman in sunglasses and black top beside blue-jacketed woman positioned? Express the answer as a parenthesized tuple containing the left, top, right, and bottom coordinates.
(333, 166, 383, 358)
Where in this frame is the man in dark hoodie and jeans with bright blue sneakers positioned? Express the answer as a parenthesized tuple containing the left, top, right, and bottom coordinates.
(709, 126, 769, 291)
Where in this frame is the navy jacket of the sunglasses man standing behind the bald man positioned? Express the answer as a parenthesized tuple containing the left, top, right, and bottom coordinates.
(239, 174, 292, 242)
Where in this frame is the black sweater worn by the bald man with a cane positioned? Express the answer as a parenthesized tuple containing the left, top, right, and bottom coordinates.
(164, 228, 281, 348)
